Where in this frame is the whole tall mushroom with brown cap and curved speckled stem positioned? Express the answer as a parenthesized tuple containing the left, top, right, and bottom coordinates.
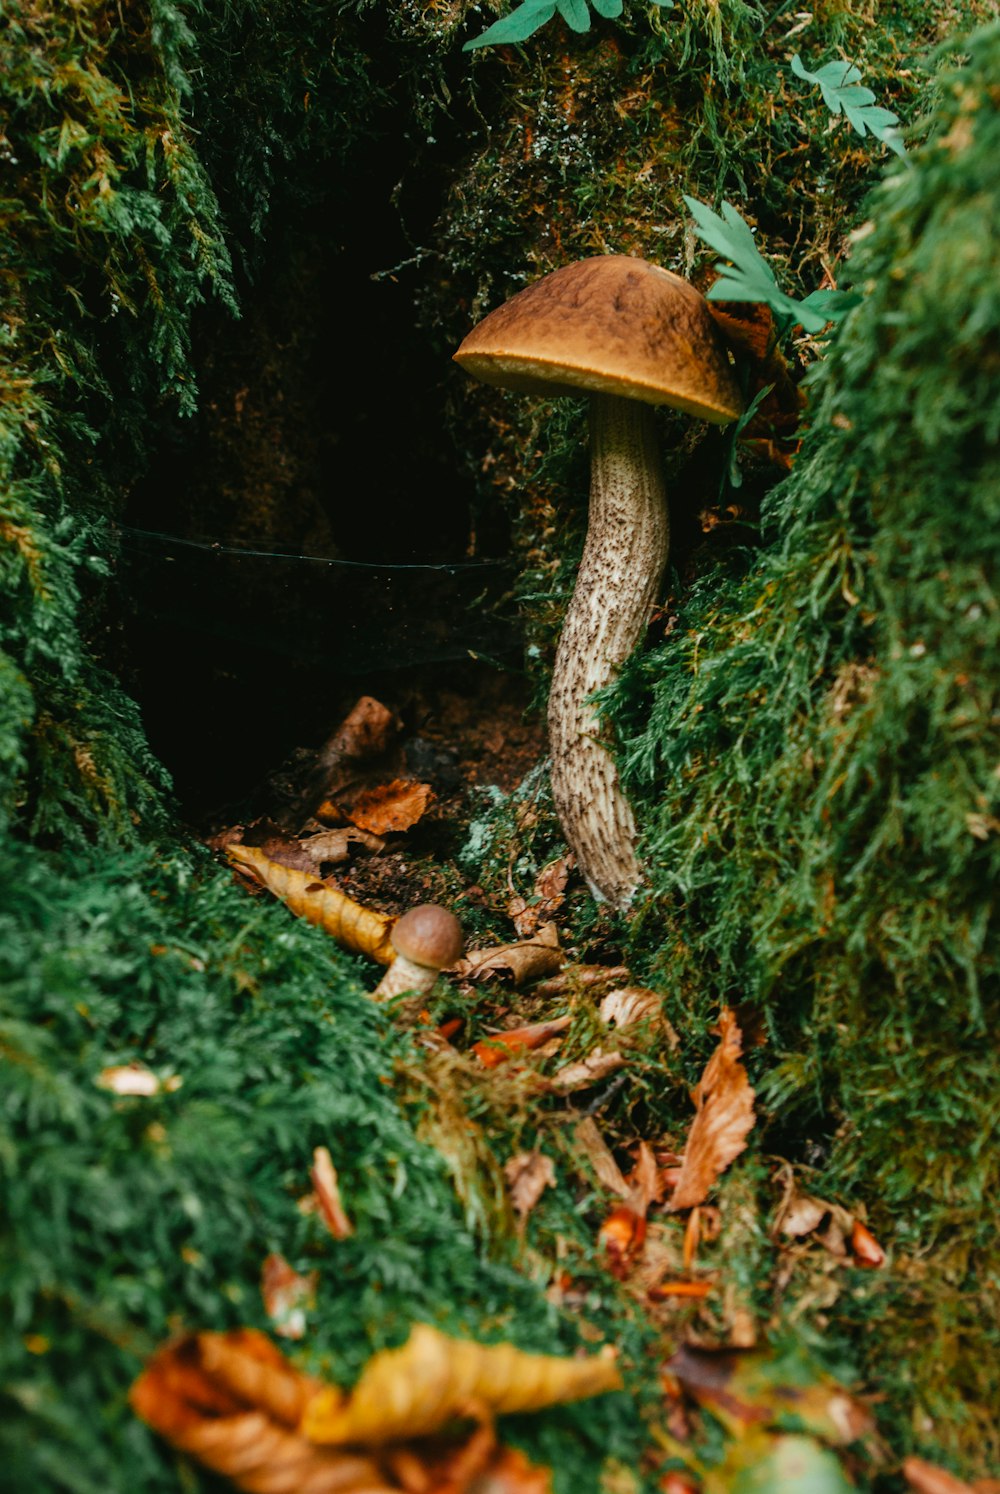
(454, 254, 743, 908)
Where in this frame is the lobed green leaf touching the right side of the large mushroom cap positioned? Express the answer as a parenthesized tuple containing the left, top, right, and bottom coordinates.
(685, 196, 861, 335)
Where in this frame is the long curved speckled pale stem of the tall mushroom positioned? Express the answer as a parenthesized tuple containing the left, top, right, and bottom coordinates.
(549, 394, 670, 908)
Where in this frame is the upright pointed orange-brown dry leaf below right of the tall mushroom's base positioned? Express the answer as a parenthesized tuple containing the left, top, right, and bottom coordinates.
(670, 1007, 755, 1209)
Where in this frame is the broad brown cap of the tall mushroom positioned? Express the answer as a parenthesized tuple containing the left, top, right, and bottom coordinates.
(454, 254, 743, 426)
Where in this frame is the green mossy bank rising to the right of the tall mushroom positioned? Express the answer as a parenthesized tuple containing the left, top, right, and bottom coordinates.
(614, 27, 1000, 1470)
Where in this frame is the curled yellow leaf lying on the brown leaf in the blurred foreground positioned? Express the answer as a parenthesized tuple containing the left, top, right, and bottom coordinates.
(300, 1324, 622, 1446)
